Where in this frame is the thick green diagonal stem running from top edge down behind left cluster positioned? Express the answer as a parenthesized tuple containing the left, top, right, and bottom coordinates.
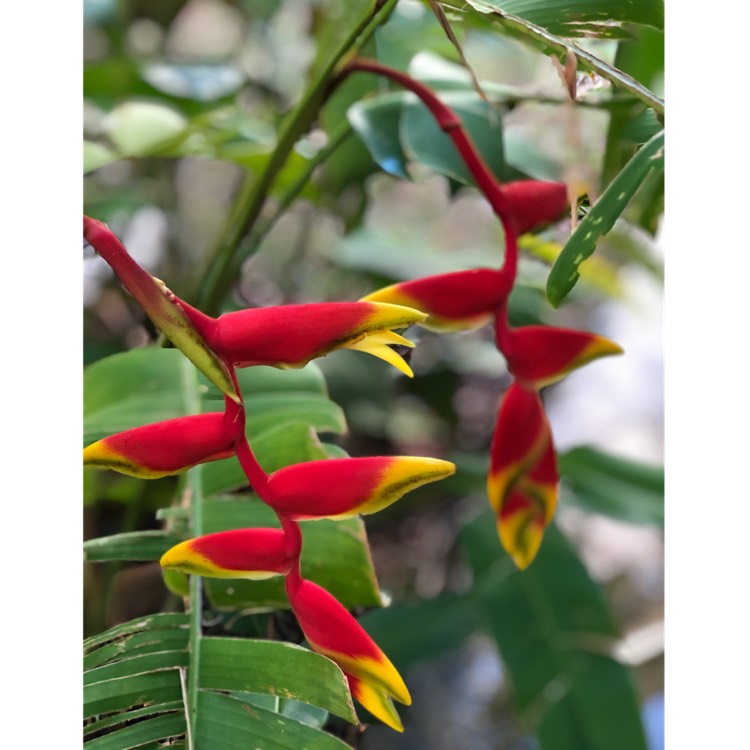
(196, 0, 397, 314)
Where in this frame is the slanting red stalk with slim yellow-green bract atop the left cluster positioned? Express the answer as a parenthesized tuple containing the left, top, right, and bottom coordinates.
(83, 216, 241, 403)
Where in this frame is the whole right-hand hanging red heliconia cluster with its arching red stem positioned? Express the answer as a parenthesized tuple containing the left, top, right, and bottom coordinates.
(345, 59, 622, 569)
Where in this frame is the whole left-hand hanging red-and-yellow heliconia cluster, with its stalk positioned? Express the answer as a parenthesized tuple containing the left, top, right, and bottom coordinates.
(83, 217, 455, 731)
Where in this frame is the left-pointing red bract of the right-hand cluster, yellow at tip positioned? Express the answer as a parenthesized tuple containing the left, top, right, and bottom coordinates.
(363, 268, 512, 333)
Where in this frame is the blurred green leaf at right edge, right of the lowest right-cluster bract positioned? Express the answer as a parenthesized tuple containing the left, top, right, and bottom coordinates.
(559, 446, 664, 528)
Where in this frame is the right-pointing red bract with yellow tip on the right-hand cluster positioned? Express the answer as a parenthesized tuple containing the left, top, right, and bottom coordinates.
(503, 326, 623, 389)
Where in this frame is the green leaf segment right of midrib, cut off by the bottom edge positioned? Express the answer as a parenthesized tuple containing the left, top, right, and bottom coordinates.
(194, 690, 350, 750)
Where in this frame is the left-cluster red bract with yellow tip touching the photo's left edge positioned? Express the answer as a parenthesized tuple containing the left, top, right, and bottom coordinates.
(83, 412, 236, 479)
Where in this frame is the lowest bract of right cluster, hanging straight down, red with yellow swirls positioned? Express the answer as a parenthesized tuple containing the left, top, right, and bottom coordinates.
(487, 383, 558, 569)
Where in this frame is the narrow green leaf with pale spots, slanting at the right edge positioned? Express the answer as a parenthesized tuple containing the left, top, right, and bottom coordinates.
(547, 131, 664, 307)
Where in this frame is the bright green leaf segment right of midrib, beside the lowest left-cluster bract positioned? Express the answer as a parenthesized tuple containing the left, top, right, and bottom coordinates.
(198, 638, 357, 723)
